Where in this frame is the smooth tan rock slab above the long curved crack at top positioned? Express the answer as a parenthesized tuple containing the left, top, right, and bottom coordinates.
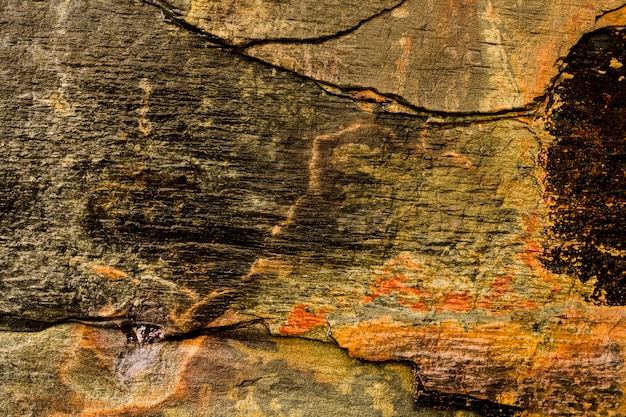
(167, 0, 624, 113)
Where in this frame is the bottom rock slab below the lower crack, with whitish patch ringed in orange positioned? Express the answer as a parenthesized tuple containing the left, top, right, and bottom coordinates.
(0, 324, 475, 417)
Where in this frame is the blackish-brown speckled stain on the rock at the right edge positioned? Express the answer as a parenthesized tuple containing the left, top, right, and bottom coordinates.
(544, 28, 626, 305)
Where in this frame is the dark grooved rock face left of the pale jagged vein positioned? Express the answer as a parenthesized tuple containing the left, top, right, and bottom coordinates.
(0, 1, 359, 332)
